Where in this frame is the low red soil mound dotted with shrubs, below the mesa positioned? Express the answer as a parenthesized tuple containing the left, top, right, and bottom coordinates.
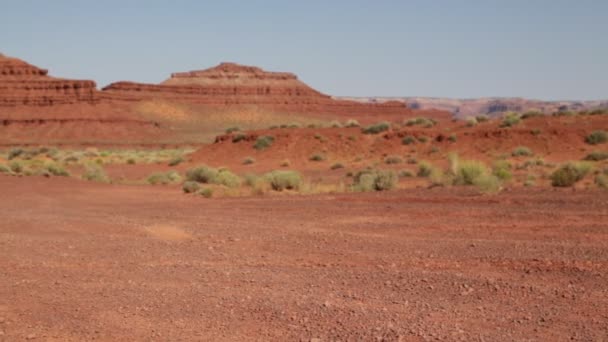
(191, 116, 608, 172)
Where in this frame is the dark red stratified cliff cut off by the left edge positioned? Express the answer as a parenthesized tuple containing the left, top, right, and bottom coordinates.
(0, 55, 98, 106)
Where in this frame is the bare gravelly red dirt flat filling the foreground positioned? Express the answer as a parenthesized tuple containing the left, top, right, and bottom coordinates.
(0, 176, 608, 341)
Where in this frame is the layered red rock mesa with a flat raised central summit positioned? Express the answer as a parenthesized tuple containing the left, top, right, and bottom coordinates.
(103, 63, 418, 116)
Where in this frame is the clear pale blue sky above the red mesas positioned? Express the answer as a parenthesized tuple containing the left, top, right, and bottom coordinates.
(0, 0, 608, 99)
